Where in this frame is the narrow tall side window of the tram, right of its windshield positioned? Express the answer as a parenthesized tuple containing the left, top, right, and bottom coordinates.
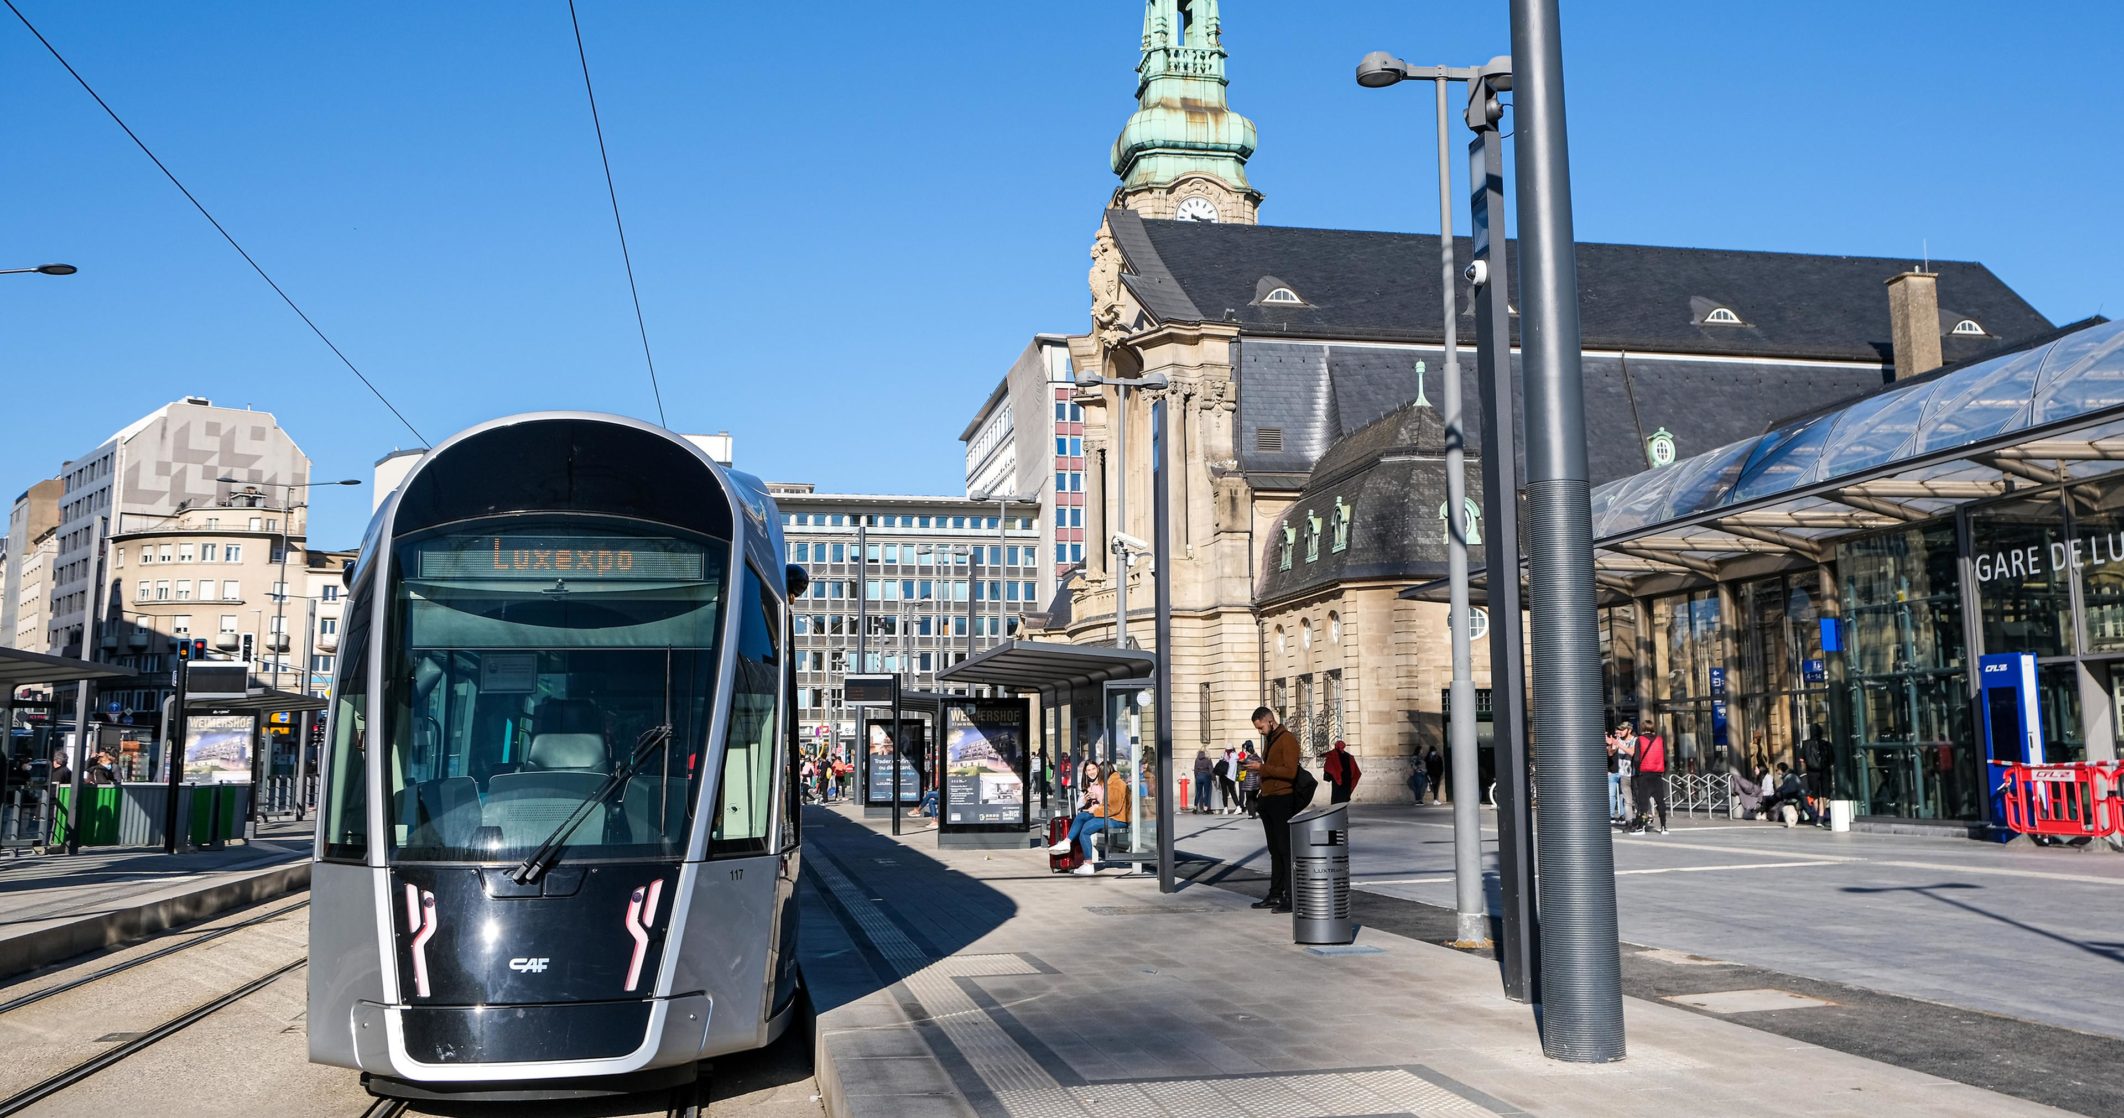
(707, 568, 782, 854)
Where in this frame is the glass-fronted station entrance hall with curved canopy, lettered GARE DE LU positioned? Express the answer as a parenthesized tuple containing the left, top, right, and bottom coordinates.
(1404, 319, 2124, 833)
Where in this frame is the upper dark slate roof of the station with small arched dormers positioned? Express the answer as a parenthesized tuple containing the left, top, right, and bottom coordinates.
(1107, 210, 2052, 363)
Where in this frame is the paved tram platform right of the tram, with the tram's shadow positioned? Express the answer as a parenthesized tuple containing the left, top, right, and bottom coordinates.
(801, 808, 2065, 1118)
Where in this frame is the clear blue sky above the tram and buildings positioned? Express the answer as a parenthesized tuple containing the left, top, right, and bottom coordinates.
(0, 0, 2124, 546)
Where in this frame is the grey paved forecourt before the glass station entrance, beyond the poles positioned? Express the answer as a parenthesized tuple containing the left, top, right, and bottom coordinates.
(1175, 806, 2124, 1041)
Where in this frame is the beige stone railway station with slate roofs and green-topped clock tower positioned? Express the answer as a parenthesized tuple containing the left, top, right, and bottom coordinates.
(994, 0, 2056, 799)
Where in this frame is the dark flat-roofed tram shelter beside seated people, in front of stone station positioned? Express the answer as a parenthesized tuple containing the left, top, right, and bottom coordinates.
(937, 640, 1170, 869)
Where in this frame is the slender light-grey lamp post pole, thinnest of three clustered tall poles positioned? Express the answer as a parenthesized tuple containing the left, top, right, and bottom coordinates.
(1417, 79, 1489, 946)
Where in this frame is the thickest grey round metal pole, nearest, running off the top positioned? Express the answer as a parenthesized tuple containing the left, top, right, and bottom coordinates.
(1500, 0, 1625, 1063)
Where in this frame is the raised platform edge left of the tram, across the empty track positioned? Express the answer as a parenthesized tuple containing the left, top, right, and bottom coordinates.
(0, 820, 312, 978)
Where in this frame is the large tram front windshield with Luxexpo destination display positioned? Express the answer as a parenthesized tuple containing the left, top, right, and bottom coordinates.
(382, 521, 729, 863)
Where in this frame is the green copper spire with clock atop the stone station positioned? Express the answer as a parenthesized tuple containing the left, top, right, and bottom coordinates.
(1113, 0, 1262, 225)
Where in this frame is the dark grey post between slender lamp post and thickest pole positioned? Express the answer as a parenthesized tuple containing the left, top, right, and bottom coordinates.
(1468, 57, 1540, 1001)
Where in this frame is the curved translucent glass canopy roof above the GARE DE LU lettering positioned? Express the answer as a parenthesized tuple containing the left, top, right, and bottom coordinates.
(1402, 321, 2124, 602)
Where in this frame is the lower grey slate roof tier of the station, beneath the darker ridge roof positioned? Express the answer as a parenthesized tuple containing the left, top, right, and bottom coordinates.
(1238, 338, 1886, 489)
